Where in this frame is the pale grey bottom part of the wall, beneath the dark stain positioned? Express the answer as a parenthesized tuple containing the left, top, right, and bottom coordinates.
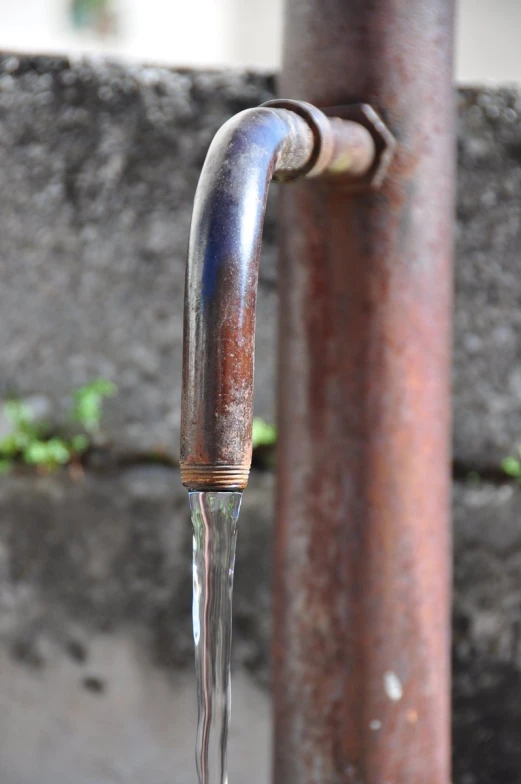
(0, 635, 270, 784)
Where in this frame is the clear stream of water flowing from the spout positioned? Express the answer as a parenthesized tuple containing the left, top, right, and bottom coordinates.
(189, 492, 242, 784)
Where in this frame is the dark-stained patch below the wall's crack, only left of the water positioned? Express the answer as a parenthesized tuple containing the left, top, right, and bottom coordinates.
(0, 466, 191, 668)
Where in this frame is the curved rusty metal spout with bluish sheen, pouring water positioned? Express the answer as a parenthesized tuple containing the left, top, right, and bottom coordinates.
(181, 101, 376, 490)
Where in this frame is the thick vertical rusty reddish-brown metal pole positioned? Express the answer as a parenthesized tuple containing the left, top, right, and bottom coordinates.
(274, 0, 454, 784)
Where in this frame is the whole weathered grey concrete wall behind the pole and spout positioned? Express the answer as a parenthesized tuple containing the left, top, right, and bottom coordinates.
(0, 56, 521, 784)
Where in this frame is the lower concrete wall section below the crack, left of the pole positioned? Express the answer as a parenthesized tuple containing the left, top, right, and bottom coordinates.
(0, 465, 273, 784)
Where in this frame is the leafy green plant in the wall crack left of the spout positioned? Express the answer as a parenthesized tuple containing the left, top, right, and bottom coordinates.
(0, 379, 117, 474)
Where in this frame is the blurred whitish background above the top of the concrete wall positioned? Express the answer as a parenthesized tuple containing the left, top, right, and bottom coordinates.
(0, 0, 521, 82)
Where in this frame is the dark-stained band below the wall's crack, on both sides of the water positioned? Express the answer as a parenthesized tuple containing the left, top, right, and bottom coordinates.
(0, 465, 273, 680)
